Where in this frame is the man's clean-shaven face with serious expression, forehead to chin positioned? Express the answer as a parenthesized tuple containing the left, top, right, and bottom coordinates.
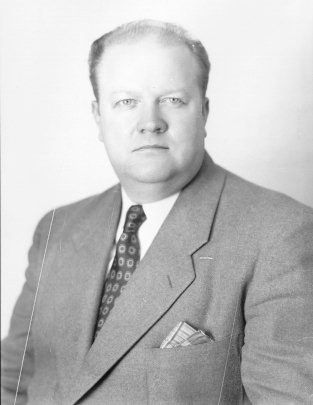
(93, 37, 208, 199)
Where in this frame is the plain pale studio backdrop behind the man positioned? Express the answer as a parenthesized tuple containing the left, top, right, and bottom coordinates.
(1, 0, 313, 336)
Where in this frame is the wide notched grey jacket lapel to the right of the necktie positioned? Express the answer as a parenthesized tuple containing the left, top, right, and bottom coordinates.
(68, 156, 225, 403)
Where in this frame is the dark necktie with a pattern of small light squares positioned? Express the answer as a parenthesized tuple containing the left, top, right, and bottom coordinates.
(95, 205, 146, 338)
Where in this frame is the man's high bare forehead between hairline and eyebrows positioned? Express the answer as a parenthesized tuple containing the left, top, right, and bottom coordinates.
(97, 37, 200, 89)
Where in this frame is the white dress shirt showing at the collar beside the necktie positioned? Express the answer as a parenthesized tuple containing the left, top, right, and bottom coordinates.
(107, 188, 179, 275)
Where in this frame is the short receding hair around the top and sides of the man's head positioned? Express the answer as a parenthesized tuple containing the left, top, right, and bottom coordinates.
(88, 20, 210, 100)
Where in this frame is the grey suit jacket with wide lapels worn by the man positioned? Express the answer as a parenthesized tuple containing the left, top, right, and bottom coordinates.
(2, 156, 313, 405)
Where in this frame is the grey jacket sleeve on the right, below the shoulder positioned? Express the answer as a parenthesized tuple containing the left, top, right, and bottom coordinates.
(241, 209, 313, 405)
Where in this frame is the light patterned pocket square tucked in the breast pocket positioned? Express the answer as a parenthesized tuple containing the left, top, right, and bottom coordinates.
(160, 322, 213, 349)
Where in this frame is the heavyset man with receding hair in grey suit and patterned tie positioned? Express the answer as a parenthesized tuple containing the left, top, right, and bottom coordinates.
(3, 21, 313, 405)
